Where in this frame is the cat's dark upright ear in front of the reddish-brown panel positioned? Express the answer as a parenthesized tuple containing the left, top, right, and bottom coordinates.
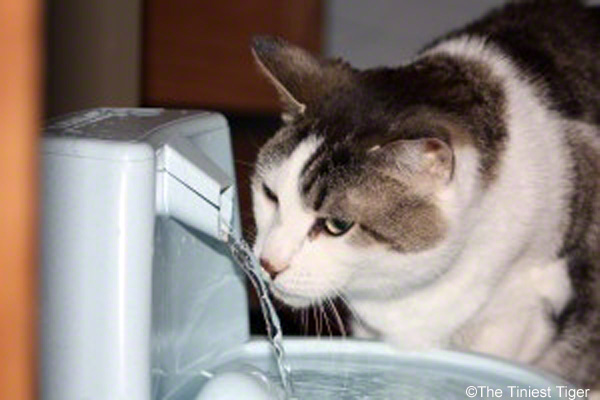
(252, 36, 349, 117)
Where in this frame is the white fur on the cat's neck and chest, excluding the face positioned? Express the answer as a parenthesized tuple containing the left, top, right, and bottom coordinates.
(351, 37, 571, 361)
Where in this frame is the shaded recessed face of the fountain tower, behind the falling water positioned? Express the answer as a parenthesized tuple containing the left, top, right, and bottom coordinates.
(152, 110, 249, 400)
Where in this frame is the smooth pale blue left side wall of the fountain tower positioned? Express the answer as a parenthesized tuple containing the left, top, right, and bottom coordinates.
(40, 139, 155, 400)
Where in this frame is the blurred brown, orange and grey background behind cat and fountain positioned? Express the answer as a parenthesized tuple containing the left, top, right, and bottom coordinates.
(5, 0, 600, 399)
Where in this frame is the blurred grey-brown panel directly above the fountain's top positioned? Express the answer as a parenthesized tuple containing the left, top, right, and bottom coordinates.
(44, 0, 142, 117)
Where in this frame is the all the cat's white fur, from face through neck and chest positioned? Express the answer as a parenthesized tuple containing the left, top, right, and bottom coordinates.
(254, 37, 571, 361)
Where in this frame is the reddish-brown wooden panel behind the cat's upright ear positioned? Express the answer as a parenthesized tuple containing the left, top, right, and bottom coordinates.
(143, 0, 322, 112)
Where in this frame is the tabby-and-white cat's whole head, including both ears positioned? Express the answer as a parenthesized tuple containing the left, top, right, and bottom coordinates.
(252, 37, 502, 307)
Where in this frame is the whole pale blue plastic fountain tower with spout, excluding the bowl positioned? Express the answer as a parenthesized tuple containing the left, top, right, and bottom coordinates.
(40, 109, 248, 400)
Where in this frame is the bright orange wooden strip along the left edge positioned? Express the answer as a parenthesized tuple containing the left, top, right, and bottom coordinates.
(0, 0, 41, 400)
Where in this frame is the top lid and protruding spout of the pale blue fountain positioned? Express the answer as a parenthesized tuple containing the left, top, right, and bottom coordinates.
(44, 108, 235, 240)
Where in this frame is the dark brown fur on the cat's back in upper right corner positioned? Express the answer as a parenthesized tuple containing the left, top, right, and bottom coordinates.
(434, 0, 600, 124)
